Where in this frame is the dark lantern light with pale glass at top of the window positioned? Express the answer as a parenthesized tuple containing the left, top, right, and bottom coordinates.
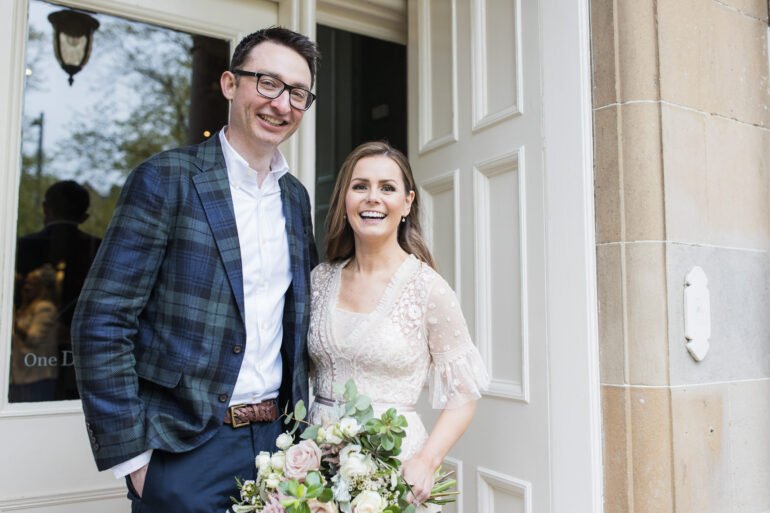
(48, 9, 99, 86)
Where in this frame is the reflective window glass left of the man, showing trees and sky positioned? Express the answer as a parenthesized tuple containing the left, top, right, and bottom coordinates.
(7, 0, 230, 402)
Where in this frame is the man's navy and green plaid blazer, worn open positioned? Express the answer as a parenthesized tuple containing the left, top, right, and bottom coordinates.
(72, 137, 318, 470)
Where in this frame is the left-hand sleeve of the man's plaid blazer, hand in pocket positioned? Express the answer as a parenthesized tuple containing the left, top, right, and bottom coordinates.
(72, 162, 169, 470)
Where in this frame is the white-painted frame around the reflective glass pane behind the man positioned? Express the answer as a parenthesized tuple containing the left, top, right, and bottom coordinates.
(0, 0, 276, 513)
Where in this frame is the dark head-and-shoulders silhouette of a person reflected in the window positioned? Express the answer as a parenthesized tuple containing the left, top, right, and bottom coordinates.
(9, 180, 101, 402)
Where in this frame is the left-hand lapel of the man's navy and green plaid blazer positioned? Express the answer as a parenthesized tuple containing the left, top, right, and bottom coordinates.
(192, 135, 245, 322)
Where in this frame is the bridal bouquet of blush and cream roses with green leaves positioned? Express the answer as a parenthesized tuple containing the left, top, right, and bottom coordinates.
(232, 381, 457, 513)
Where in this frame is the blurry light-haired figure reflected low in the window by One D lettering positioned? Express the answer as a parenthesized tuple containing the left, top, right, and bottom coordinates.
(8, 264, 59, 402)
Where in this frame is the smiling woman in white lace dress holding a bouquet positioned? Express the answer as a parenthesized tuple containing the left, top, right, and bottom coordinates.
(308, 142, 488, 511)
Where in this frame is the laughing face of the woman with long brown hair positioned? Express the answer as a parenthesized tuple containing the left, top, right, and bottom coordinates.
(345, 155, 414, 244)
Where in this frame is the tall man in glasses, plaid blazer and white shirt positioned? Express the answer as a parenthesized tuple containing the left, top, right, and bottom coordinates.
(72, 27, 319, 513)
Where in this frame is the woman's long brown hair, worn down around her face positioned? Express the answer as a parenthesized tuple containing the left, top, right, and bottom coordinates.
(326, 141, 436, 268)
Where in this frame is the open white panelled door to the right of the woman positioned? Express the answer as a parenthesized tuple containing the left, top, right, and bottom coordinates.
(409, 0, 595, 513)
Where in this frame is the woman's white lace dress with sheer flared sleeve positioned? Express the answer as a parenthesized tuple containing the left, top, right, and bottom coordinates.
(308, 255, 488, 508)
